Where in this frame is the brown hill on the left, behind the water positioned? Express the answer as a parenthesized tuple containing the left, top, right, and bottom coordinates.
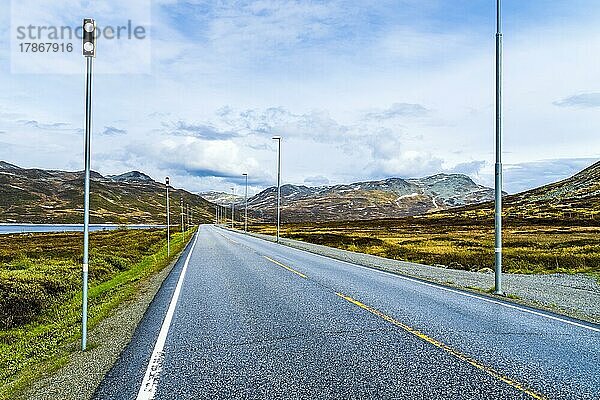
(0, 161, 214, 224)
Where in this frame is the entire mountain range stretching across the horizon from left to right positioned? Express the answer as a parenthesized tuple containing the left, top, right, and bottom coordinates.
(0, 161, 600, 224)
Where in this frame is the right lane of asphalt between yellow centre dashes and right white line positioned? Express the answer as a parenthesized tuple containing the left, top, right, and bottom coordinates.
(221, 230, 600, 399)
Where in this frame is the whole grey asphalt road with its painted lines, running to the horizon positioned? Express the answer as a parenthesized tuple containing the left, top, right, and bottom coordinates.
(96, 225, 600, 399)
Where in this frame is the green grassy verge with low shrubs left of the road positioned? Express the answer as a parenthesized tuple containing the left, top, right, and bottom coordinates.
(0, 230, 191, 399)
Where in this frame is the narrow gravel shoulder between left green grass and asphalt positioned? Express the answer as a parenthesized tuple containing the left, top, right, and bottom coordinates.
(21, 243, 189, 400)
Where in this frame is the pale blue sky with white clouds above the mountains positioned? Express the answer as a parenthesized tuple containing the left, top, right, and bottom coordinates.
(0, 0, 600, 192)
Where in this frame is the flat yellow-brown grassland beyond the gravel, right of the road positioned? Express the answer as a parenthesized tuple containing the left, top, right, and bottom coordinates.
(252, 218, 600, 274)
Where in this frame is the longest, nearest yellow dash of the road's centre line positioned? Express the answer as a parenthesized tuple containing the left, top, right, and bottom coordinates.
(336, 292, 546, 400)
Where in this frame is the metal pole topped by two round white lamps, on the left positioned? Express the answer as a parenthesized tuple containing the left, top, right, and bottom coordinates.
(81, 18, 96, 351)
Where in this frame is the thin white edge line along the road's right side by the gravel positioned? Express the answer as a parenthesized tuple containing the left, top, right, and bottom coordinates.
(220, 227, 600, 332)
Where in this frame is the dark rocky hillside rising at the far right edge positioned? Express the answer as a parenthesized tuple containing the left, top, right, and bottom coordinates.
(430, 161, 600, 222)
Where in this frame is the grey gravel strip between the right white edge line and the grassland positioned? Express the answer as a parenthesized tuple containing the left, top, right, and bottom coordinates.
(245, 233, 600, 323)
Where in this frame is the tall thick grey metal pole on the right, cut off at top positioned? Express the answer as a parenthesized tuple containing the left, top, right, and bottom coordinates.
(494, 0, 504, 295)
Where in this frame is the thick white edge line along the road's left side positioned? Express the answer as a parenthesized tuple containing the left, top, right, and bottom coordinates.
(137, 230, 200, 400)
